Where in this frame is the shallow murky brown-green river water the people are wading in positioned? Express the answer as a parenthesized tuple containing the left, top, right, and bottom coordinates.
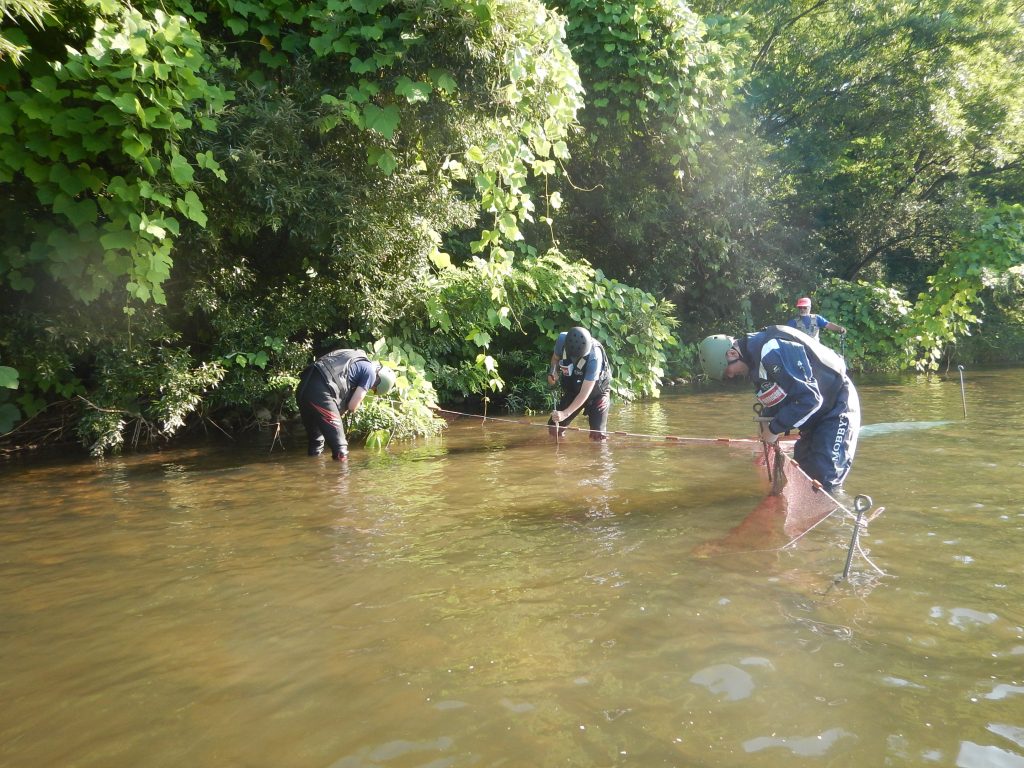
(0, 370, 1024, 768)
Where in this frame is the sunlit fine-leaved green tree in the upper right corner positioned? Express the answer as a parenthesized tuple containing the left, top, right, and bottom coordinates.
(744, 0, 1024, 286)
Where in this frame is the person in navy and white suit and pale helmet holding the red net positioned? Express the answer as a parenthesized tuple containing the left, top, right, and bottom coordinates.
(699, 326, 860, 490)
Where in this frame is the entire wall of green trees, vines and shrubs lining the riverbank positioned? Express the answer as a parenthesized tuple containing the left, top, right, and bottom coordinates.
(0, 0, 1024, 455)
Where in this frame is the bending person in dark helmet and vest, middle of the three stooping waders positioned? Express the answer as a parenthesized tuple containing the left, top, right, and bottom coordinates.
(548, 326, 611, 440)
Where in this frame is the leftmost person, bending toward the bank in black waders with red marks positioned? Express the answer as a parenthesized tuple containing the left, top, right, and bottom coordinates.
(295, 349, 396, 461)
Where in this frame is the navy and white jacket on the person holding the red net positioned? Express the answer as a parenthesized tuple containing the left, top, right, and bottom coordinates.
(739, 326, 853, 434)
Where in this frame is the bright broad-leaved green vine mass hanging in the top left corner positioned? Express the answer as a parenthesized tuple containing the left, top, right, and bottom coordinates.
(0, 2, 228, 303)
